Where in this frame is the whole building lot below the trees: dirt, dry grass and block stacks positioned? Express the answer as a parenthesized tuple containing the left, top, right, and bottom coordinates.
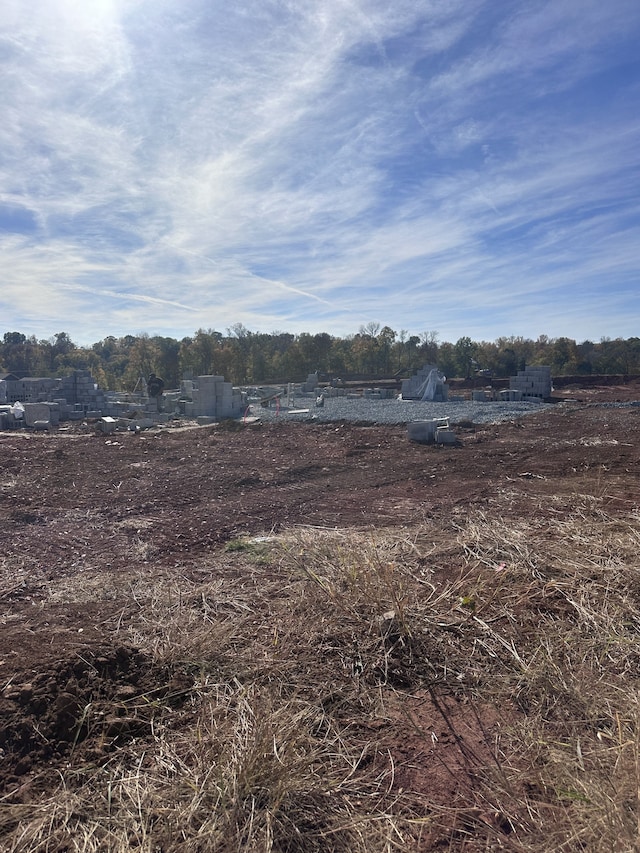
(0, 371, 640, 853)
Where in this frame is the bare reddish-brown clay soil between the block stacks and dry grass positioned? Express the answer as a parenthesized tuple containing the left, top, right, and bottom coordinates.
(0, 383, 640, 844)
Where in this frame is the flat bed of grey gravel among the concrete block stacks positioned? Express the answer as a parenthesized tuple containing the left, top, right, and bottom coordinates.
(249, 397, 553, 424)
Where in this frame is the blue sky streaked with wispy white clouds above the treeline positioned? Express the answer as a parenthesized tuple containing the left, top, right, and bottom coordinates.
(0, 0, 640, 344)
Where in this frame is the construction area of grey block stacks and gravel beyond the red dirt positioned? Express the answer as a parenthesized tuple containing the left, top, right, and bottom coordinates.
(0, 365, 552, 444)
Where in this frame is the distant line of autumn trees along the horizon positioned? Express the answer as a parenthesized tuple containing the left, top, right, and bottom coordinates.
(0, 323, 640, 391)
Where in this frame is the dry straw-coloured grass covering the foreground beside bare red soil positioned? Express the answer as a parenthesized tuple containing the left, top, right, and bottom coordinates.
(0, 497, 640, 853)
